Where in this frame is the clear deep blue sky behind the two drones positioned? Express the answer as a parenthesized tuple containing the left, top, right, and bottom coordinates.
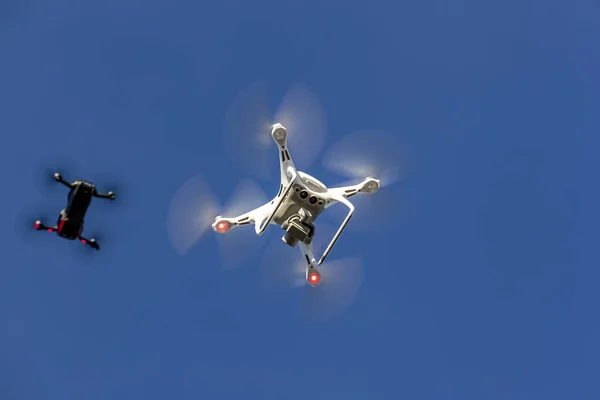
(0, 0, 600, 400)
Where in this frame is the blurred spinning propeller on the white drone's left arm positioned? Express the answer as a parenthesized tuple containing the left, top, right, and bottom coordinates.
(167, 176, 268, 269)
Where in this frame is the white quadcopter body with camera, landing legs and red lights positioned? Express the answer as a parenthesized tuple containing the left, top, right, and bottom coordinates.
(212, 123, 379, 287)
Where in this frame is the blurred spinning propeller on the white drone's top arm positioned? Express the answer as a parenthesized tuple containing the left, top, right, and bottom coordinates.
(224, 83, 326, 179)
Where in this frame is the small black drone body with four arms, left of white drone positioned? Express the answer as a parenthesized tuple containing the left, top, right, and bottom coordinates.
(34, 172, 115, 250)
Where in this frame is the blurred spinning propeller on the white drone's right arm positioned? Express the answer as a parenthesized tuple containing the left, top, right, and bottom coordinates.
(323, 131, 406, 232)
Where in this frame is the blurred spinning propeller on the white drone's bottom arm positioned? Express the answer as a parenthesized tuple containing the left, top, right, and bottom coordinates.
(260, 223, 364, 322)
